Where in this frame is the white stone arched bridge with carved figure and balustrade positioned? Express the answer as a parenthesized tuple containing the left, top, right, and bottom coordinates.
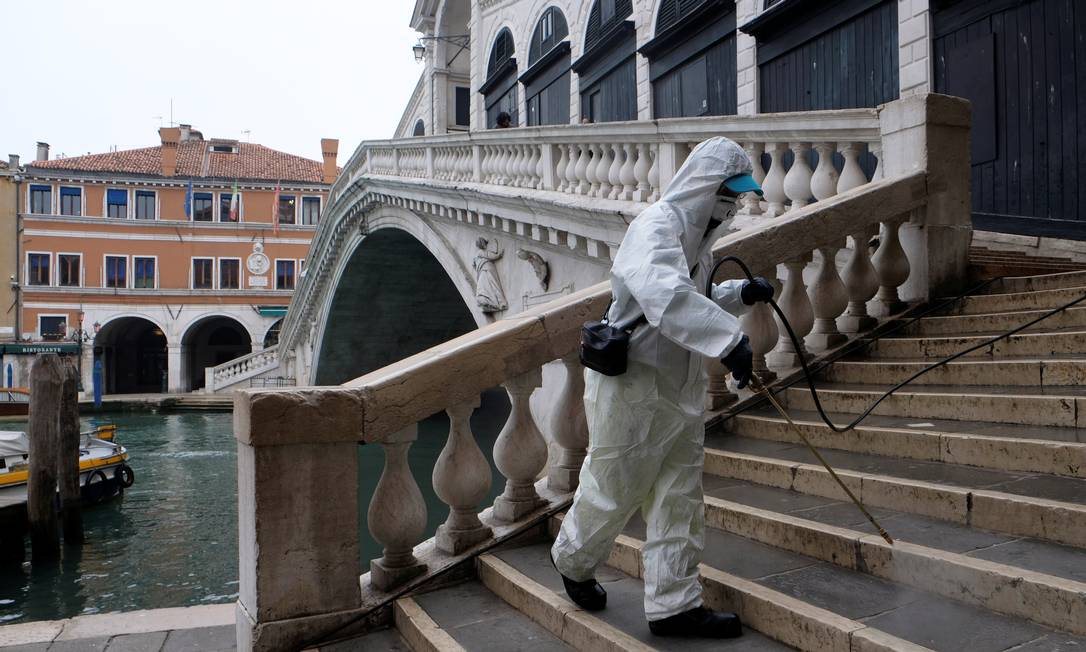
(209, 104, 899, 391)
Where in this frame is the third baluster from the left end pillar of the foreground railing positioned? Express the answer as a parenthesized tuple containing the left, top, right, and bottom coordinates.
(493, 368, 547, 523)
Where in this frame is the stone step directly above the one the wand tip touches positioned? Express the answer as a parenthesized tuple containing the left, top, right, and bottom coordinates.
(705, 436, 1086, 548)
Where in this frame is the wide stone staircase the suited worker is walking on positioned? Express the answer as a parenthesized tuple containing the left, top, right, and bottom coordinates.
(320, 267, 1086, 652)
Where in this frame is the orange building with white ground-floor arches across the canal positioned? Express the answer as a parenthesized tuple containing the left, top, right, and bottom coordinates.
(4, 125, 338, 393)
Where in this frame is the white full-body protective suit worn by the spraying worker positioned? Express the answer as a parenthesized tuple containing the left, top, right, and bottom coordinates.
(552, 138, 752, 620)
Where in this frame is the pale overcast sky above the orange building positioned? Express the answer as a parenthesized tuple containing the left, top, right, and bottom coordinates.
(0, 0, 422, 164)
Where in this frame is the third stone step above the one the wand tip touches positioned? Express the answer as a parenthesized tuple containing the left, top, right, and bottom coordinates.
(779, 384, 1086, 428)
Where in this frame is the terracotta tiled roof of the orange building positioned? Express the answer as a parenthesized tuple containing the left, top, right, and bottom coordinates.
(30, 140, 324, 184)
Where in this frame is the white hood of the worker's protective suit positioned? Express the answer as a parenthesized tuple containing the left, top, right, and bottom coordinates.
(659, 137, 753, 260)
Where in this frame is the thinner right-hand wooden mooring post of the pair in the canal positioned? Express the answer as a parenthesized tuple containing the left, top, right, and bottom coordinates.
(59, 363, 84, 546)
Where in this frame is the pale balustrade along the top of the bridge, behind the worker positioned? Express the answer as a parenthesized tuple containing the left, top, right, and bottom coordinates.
(280, 109, 883, 358)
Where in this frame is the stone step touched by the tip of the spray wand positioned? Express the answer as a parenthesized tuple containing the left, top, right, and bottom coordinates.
(706, 481, 1086, 636)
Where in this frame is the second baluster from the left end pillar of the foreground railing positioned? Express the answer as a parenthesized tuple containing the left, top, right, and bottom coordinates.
(433, 398, 491, 554)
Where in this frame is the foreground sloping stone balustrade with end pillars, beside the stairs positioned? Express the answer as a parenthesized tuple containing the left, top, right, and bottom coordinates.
(235, 96, 970, 650)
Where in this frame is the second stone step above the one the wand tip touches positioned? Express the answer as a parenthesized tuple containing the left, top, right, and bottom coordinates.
(721, 409, 1086, 478)
